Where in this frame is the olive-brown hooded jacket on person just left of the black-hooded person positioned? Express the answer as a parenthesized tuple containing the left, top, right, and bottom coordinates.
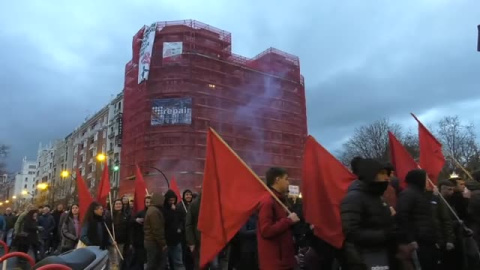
(143, 193, 167, 249)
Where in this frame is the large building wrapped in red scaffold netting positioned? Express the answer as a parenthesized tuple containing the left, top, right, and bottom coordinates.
(120, 20, 307, 194)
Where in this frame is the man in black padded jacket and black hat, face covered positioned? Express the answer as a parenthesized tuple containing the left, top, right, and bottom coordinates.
(341, 159, 396, 270)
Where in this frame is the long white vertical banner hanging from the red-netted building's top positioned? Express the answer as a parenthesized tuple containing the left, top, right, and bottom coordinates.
(138, 23, 157, 84)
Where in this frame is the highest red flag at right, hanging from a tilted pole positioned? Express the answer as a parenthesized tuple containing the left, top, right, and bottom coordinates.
(412, 113, 445, 184)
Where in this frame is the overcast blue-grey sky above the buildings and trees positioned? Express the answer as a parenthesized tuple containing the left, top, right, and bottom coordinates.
(0, 0, 480, 170)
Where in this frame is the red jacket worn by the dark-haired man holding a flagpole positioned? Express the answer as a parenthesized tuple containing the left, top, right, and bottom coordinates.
(258, 191, 296, 270)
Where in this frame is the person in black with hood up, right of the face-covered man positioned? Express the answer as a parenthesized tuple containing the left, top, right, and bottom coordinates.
(397, 169, 438, 270)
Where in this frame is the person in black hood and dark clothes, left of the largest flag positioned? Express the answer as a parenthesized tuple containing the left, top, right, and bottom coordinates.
(163, 190, 185, 270)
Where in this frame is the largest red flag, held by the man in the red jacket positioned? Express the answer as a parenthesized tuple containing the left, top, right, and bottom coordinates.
(197, 129, 268, 268)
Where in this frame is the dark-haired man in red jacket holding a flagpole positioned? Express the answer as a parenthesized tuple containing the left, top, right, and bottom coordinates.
(257, 168, 300, 270)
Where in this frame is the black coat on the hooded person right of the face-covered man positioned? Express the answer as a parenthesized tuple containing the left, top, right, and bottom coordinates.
(397, 185, 438, 245)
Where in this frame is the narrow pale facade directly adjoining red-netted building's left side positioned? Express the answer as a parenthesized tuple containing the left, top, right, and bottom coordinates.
(107, 92, 123, 198)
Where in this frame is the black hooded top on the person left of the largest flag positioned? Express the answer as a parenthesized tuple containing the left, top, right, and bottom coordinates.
(163, 190, 184, 246)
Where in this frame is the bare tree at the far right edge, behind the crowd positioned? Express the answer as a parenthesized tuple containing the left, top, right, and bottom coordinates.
(437, 116, 480, 172)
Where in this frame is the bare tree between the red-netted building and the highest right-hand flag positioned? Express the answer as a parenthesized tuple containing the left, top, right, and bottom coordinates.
(340, 118, 418, 164)
